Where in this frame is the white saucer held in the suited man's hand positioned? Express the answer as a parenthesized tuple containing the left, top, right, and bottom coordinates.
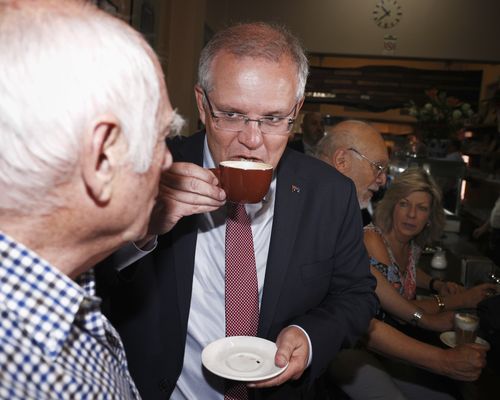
(201, 336, 288, 382)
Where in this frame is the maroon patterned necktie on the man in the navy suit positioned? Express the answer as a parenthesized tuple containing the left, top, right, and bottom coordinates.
(224, 202, 259, 400)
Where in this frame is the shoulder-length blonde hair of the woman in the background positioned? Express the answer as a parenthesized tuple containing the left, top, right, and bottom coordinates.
(373, 167, 445, 246)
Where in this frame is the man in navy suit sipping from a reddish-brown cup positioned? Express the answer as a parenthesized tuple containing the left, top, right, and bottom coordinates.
(99, 23, 378, 399)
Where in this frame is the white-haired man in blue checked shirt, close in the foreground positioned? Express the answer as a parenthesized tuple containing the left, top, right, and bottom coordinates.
(0, 0, 184, 399)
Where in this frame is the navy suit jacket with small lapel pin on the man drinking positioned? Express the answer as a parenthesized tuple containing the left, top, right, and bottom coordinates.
(98, 132, 378, 400)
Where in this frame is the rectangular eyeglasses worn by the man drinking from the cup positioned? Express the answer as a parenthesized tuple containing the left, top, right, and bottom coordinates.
(203, 90, 298, 135)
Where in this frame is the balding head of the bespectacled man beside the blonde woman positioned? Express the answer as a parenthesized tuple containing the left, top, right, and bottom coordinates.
(317, 120, 389, 207)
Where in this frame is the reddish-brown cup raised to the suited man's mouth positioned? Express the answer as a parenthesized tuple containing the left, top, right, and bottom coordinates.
(211, 160, 273, 203)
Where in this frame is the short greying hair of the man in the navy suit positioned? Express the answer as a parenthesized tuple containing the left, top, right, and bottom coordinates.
(198, 22, 309, 101)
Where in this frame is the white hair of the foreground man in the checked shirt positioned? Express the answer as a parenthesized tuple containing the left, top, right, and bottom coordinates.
(0, 0, 162, 211)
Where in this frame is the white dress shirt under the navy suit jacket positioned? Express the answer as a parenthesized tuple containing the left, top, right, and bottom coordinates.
(171, 139, 276, 400)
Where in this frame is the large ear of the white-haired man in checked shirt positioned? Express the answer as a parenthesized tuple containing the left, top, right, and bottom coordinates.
(81, 117, 122, 204)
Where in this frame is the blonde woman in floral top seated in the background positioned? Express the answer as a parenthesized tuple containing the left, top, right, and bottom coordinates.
(365, 168, 495, 312)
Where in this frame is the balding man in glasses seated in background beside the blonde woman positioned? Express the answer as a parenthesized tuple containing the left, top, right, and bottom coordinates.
(317, 120, 486, 399)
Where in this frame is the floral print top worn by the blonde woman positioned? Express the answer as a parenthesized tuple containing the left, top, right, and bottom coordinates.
(364, 224, 422, 300)
